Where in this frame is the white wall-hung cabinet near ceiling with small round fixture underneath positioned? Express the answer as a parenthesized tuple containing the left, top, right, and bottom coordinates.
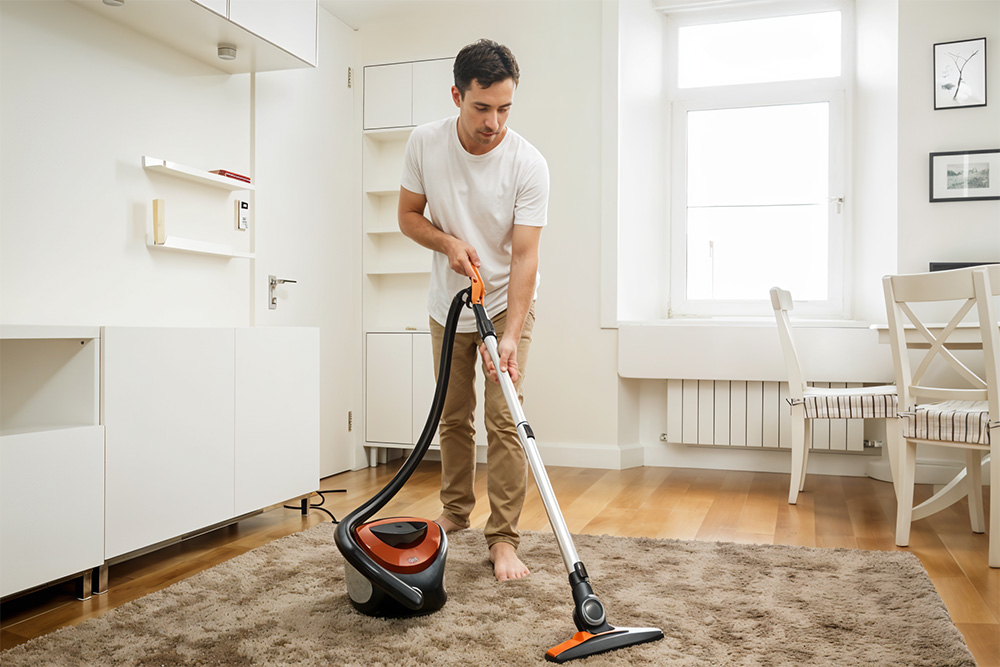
(73, 0, 317, 74)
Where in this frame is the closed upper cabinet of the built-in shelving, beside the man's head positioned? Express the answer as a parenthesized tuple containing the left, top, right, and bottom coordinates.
(364, 58, 458, 130)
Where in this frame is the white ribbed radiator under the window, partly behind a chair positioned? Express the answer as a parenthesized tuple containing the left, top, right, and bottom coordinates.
(665, 380, 864, 452)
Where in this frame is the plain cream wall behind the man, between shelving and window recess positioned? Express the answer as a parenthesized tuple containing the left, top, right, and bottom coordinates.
(350, 0, 618, 465)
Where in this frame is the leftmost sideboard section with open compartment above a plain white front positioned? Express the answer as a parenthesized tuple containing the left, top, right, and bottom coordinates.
(0, 326, 104, 597)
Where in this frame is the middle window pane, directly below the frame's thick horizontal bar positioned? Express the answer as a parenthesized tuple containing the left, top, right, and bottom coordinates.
(687, 102, 830, 207)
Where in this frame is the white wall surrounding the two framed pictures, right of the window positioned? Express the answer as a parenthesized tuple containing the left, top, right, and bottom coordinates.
(897, 0, 1000, 273)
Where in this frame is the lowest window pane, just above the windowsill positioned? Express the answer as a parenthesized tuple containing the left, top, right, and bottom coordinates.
(687, 204, 828, 301)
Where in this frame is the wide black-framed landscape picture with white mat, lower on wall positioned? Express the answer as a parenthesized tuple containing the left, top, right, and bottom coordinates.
(930, 148, 1000, 202)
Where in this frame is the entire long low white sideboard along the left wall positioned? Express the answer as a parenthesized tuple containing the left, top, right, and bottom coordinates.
(0, 326, 319, 597)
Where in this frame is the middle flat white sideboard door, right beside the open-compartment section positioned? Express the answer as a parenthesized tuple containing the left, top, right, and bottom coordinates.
(102, 327, 235, 559)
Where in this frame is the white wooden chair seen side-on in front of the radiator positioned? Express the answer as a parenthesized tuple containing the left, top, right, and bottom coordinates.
(771, 287, 898, 505)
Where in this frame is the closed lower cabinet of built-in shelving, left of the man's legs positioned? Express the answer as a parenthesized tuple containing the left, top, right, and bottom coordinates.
(365, 332, 439, 447)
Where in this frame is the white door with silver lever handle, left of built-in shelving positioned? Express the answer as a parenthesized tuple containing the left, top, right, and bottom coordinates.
(251, 9, 361, 477)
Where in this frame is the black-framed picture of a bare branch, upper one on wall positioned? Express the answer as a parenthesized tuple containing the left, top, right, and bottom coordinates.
(934, 37, 986, 110)
